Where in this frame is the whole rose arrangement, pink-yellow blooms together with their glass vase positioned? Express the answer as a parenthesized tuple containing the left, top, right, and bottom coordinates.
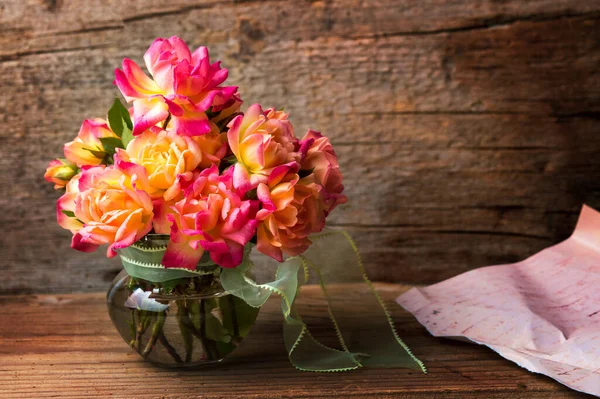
(45, 37, 424, 369)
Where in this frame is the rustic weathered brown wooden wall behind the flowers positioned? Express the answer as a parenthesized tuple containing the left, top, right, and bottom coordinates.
(0, 0, 600, 293)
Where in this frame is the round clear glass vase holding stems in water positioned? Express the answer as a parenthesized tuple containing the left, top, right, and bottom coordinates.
(107, 238, 259, 367)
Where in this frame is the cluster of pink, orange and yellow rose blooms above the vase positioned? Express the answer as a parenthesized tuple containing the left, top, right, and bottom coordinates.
(45, 37, 346, 269)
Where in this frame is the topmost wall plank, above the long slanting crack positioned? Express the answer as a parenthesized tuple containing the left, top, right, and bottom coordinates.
(0, 0, 600, 58)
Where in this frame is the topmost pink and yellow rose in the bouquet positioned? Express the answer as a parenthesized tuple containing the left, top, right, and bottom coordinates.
(114, 36, 237, 136)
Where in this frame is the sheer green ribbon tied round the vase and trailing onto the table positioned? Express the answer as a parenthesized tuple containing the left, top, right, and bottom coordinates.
(119, 229, 426, 372)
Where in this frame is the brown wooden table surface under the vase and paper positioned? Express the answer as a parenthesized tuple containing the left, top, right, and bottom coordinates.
(0, 284, 589, 399)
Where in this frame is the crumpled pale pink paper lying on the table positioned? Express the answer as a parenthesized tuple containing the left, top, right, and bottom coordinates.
(397, 206, 600, 396)
